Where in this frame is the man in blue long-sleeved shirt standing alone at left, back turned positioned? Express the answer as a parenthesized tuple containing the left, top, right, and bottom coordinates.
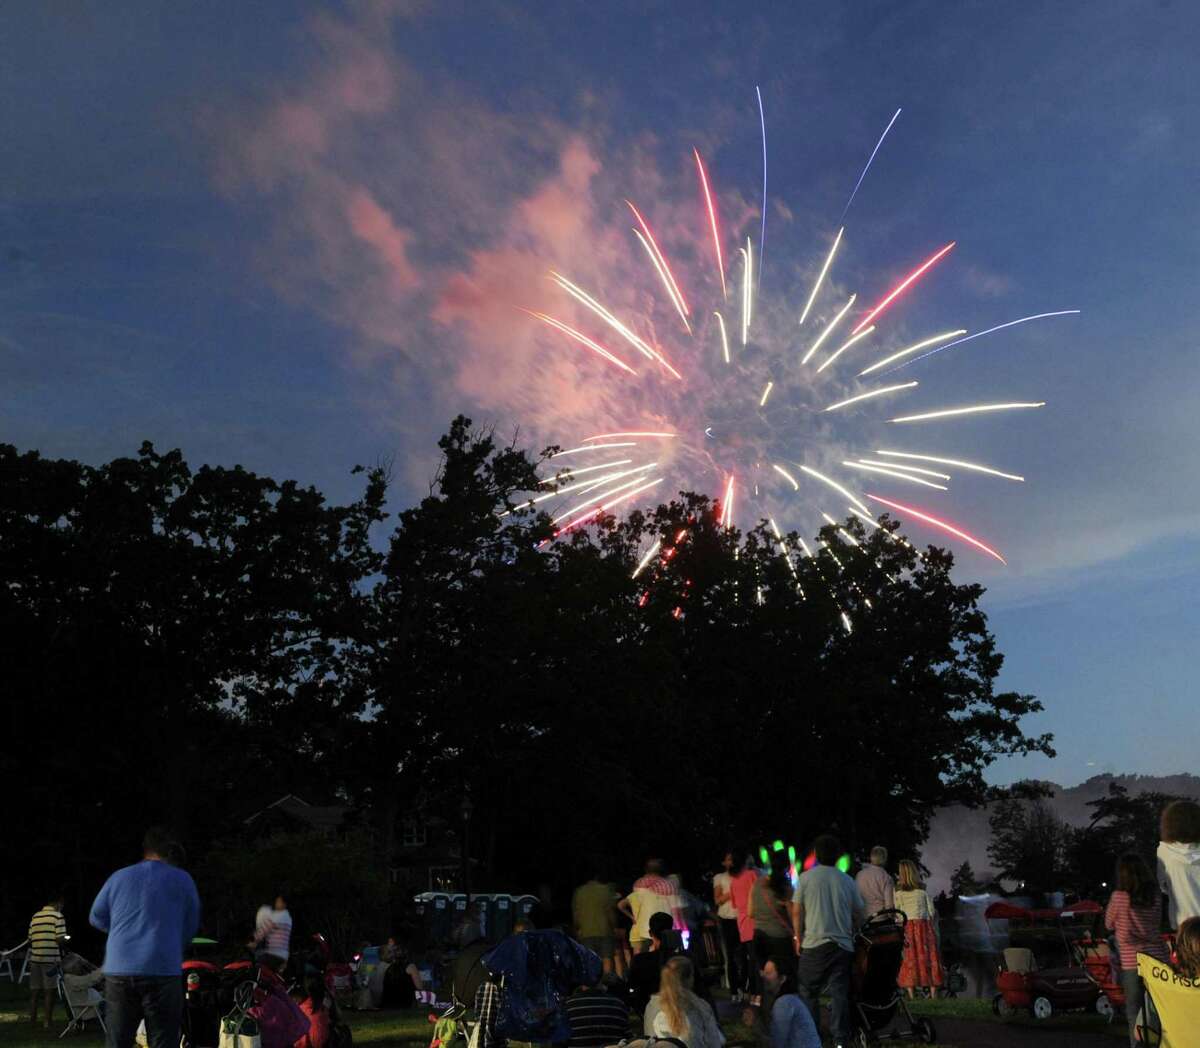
(89, 827, 200, 1048)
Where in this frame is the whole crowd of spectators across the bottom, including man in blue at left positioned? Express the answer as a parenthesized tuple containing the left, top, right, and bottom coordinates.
(16, 801, 1200, 1048)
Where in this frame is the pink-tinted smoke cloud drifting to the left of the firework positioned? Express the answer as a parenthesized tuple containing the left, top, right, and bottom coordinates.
(205, 8, 756, 448)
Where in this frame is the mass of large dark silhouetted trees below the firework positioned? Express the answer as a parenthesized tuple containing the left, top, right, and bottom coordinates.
(0, 418, 1051, 941)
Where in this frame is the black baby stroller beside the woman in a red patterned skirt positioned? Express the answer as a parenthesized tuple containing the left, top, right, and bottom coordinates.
(851, 910, 937, 1048)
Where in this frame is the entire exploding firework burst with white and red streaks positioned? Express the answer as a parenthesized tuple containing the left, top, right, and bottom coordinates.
(511, 97, 1078, 576)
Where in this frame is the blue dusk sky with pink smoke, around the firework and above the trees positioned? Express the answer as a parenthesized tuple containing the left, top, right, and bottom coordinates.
(0, 0, 1200, 783)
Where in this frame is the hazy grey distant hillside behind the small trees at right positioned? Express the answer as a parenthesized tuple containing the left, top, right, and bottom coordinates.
(922, 774, 1200, 893)
